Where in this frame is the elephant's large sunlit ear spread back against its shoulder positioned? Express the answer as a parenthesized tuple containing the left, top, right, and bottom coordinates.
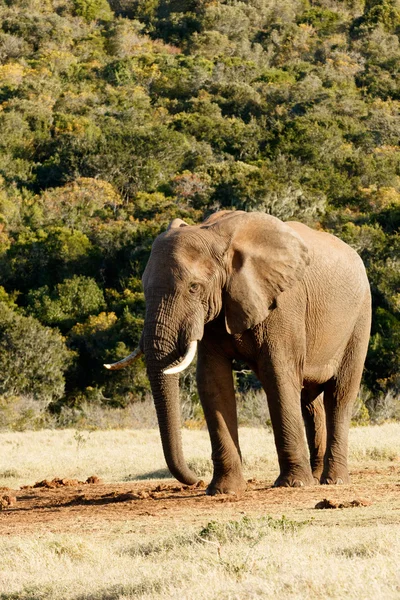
(213, 212, 309, 333)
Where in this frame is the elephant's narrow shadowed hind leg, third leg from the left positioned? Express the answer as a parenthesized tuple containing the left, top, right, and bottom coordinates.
(301, 386, 326, 483)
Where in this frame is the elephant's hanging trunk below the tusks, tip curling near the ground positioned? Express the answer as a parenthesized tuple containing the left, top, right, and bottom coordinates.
(146, 352, 197, 485)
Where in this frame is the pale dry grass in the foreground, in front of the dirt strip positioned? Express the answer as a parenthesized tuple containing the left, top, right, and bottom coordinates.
(0, 518, 400, 600)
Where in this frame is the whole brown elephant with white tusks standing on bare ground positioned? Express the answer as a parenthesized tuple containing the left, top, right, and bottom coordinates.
(105, 210, 371, 495)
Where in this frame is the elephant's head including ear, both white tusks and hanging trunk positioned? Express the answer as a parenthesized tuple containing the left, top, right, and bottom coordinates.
(106, 211, 308, 484)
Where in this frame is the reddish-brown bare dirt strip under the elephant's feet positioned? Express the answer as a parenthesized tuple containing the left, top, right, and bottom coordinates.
(0, 465, 400, 535)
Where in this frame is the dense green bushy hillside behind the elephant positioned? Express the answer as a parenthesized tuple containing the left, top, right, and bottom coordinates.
(0, 0, 400, 422)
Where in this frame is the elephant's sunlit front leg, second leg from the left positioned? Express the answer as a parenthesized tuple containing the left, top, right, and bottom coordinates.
(261, 369, 315, 487)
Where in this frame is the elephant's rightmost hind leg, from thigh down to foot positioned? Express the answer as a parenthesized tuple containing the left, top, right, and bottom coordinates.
(321, 310, 370, 484)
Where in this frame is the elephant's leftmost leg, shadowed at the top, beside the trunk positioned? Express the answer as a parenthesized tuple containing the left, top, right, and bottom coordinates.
(197, 343, 246, 496)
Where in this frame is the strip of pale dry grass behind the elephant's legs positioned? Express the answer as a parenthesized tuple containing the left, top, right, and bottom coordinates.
(0, 423, 400, 487)
